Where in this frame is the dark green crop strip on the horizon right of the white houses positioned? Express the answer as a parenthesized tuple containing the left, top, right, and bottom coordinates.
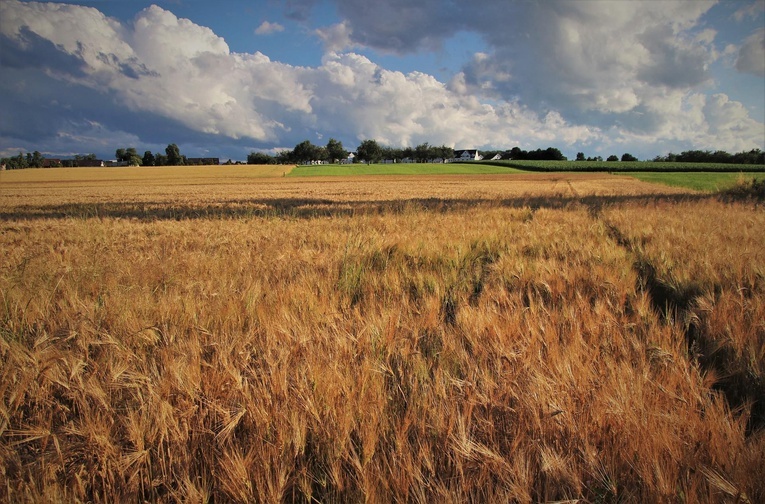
(481, 160, 765, 173)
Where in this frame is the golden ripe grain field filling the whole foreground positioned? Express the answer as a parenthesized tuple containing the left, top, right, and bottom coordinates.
(0, 167, 765, 503)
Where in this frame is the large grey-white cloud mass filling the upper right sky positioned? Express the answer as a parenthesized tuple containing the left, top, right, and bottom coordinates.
(308, 0, 765, 152)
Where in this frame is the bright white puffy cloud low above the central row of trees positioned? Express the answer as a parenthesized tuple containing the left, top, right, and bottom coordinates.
(307, 54, 597, 147)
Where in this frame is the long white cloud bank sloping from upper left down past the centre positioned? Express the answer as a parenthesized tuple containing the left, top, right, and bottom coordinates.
(2, 2, 592, 154)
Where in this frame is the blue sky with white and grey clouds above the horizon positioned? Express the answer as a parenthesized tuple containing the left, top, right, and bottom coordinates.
(0, 0, 765, 160)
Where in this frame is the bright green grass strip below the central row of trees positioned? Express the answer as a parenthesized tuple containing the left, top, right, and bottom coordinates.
(287, 163, 522, 177)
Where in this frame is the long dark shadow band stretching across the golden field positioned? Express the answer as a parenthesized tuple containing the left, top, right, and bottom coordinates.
(0, 194, 715, 221)
